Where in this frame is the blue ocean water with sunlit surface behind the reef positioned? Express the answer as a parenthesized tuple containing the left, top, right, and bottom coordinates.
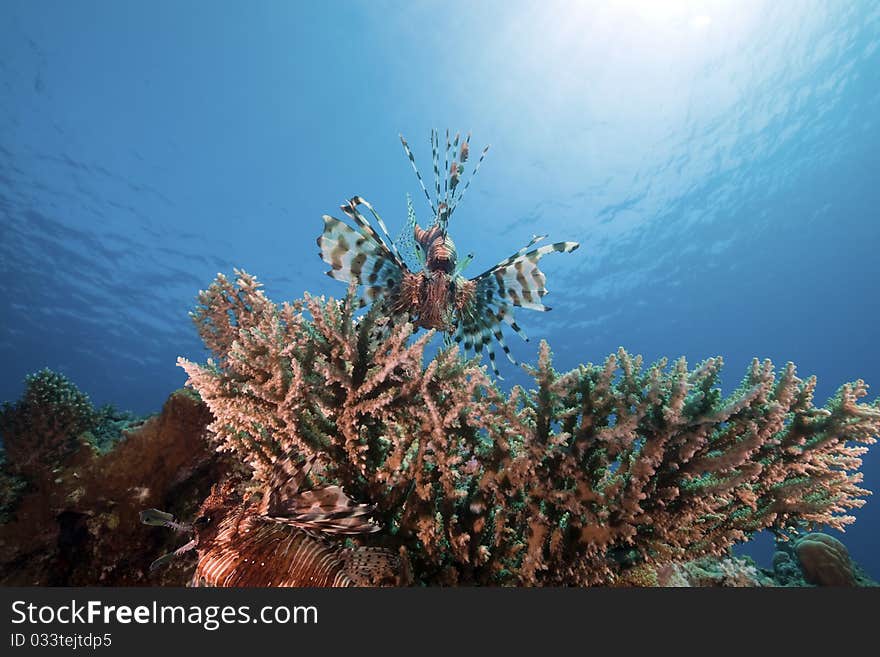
(0, 0, 880, 577)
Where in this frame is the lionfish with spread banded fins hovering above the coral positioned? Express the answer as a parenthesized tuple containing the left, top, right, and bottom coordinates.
(318, 130, 579, 378)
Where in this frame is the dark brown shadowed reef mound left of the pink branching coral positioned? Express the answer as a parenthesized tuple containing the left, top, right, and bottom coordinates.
(0, 382, 236, 586)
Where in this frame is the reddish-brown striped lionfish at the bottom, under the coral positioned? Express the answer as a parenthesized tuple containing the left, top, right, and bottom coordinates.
(141, 457, 405, 587)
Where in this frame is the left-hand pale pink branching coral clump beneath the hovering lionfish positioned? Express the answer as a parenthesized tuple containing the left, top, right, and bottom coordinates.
(180, 273, 503, 577)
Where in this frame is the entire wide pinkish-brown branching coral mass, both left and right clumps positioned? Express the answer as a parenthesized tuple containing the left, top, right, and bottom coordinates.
(179, 272, 880, 585)
